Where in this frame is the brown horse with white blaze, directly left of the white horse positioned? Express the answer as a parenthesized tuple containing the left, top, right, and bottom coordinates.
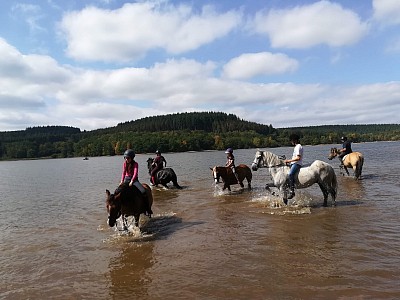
(210, 164, 253, 191)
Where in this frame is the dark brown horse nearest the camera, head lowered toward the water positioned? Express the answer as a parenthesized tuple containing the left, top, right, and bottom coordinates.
(106, 183, 153, 230)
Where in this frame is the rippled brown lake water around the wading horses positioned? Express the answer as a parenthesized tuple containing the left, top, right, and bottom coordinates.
(0, 142, 400, 299)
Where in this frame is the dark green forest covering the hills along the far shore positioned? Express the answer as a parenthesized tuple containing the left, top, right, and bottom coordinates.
(0, 112, 400, 160)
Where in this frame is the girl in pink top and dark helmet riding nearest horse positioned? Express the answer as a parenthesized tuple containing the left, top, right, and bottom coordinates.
(119, 149, 153, 217)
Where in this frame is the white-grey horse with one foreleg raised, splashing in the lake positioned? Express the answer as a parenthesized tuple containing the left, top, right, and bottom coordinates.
(251, 150, 337, 206)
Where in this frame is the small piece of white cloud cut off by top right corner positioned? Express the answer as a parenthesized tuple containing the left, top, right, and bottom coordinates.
(372, 0, 400, 25)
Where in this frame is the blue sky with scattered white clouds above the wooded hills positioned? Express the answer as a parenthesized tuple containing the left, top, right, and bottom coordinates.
(0, 0, 400, 131)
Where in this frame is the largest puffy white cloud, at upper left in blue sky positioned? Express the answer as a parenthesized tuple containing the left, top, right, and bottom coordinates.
(60, 2, 241, 62)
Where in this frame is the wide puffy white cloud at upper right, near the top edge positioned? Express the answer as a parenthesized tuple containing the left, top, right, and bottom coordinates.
(253, 0, 368, 49)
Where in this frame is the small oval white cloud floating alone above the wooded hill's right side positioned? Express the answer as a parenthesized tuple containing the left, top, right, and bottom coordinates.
(223, 52, 299, 79)
